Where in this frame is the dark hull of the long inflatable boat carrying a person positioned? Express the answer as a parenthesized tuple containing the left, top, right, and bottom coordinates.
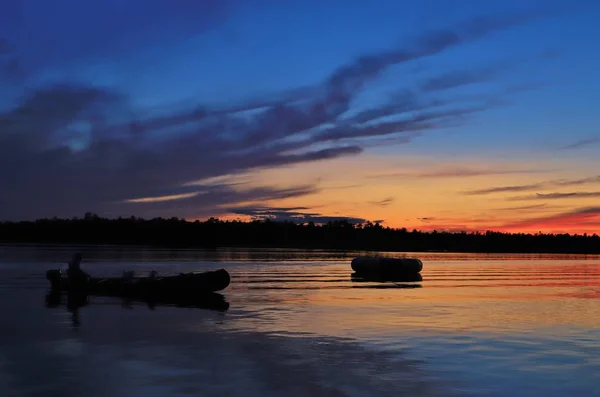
(46, 269, 231, 301)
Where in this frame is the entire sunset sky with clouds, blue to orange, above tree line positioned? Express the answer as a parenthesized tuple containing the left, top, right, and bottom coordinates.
(0, 0, 600, 233)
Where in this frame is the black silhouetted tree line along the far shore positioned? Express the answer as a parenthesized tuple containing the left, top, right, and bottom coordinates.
(0, 213, 600, 254)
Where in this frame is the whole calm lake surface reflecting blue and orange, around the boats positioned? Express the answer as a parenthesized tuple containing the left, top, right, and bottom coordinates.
(0, 246, 600, 397)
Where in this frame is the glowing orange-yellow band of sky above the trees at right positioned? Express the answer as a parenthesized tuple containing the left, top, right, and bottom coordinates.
(184, 155, 600, 234)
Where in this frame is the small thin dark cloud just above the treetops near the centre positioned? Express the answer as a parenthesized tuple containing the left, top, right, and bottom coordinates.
(228, 207, 367, 224)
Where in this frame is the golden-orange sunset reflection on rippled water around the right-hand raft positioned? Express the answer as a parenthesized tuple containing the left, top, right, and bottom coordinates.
(223, 259, 600, 335)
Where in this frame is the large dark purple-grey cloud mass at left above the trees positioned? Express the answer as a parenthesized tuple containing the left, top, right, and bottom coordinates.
(0, 79, 370, 217)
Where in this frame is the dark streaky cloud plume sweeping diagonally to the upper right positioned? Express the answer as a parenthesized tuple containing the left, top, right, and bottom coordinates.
(226, 8, 539, 148)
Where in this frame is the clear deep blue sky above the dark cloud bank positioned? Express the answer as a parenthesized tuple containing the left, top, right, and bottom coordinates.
(2, 0, 600, 147)
